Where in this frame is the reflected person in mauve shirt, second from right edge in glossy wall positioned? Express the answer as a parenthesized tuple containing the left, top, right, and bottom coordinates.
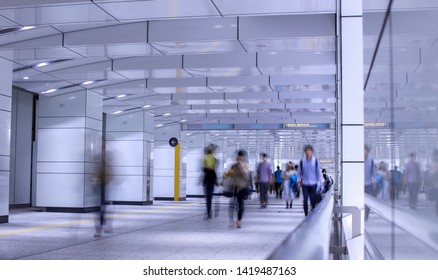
(405, 153, 421, 210)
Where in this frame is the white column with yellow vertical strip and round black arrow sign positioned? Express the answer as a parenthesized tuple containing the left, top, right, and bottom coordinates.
(153, 124, 187, 201)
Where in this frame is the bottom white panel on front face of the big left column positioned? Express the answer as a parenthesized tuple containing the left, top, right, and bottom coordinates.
(37, 173, 84, 207)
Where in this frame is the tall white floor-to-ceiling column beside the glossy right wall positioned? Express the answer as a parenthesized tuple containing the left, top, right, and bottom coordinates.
(337, 0, 364, 259)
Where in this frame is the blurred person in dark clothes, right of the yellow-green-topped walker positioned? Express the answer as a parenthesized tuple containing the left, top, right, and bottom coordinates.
(226, 150, 250, 228)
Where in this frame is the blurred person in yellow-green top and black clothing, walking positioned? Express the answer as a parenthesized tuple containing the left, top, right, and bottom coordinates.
(203, 144, 217, 219)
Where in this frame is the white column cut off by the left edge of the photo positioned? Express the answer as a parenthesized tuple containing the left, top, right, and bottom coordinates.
(0, 52, 13, 223)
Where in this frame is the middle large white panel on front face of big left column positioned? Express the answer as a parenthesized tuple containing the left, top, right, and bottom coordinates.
(38, 129, 85, 162)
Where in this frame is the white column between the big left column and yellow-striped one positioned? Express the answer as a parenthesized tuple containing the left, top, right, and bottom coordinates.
(105, 111, 154, 205)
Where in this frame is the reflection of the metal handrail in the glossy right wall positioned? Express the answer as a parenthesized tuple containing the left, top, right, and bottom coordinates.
(365, 194, 438, 251)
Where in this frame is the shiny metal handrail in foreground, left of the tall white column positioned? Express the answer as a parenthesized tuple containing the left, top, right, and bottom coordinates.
(268, 190, 334, 260)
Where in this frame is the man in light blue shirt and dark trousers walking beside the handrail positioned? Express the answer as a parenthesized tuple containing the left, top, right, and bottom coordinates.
(298, 145, 322, 216)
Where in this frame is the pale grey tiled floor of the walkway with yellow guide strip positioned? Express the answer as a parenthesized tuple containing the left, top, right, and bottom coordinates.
(0, 194, 304, 260)
